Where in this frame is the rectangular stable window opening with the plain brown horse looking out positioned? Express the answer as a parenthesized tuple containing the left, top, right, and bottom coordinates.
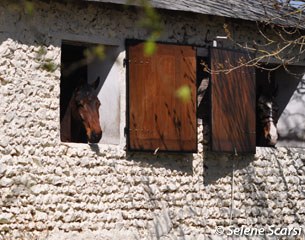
(60, 41, 120, 144)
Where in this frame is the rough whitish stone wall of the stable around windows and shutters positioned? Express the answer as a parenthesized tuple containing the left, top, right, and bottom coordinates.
(0, 1, 305, 240)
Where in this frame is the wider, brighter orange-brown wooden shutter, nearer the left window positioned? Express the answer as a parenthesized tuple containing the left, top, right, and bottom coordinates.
(127, 42, 197, 152)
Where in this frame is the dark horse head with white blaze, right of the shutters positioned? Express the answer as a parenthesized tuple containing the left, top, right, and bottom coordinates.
(256, 87, 279, 147)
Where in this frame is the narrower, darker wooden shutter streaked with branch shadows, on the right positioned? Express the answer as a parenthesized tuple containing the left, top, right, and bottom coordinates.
(211, 48, 256, 153)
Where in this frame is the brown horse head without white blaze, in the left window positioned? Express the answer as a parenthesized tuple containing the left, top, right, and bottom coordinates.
(73, 77, 102, 143)
